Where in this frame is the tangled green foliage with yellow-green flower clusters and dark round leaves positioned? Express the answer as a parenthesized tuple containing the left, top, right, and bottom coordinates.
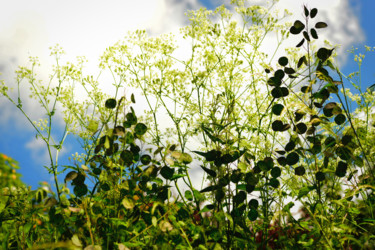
(0, 1, 375, 249)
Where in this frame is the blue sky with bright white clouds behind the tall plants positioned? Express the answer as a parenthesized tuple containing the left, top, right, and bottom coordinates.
(0, 0, 375, 189)
